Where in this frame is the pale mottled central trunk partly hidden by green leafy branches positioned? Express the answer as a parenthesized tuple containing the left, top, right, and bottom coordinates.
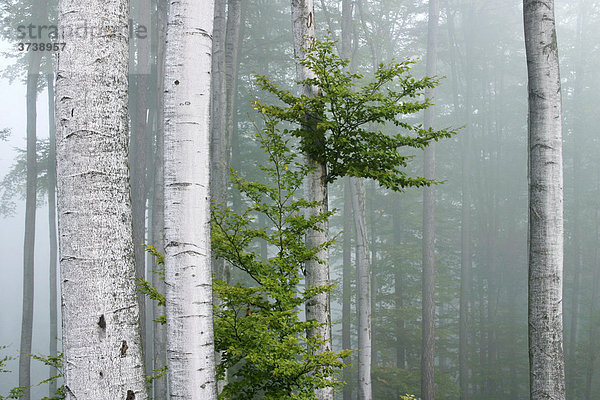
(292, 0, 333, 400)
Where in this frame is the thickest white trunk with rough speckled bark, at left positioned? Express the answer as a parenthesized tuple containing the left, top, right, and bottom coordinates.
(56, 0, 147, 400)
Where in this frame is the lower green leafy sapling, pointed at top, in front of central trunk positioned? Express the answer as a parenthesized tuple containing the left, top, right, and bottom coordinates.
(212, 122, 348, 400)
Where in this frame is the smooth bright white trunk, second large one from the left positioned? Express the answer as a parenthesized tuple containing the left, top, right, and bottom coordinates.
(164, 0, 217, 400)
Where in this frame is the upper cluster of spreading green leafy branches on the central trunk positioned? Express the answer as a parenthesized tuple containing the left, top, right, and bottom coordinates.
(253, 40, 455, 191)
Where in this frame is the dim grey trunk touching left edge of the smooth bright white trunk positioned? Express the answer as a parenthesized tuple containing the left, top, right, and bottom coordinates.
(151, 0, 169, 400)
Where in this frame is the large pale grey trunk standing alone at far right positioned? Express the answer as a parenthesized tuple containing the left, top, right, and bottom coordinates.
(523, 0, 565, 400)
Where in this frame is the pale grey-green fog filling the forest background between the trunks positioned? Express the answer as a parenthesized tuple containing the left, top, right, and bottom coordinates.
(0, 0, 600, 400)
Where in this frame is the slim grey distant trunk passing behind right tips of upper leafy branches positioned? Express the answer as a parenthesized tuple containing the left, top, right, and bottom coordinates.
(421, 0, 440, 400)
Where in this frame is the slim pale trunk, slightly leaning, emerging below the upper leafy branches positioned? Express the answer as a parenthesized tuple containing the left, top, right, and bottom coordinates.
(351, 178, 373, 400)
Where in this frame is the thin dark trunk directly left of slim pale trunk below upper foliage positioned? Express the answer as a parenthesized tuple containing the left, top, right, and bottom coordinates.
(342, 177, 352, 400)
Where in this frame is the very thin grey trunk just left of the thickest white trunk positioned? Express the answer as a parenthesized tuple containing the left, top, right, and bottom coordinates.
(46, 74, 58, 397)
